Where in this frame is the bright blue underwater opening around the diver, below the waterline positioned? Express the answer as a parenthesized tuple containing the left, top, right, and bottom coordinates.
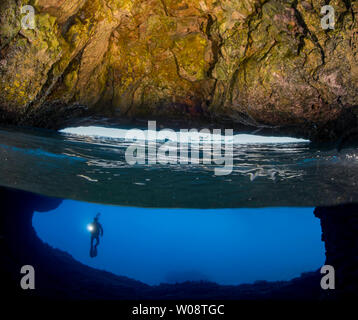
(33, 200, 325, 284)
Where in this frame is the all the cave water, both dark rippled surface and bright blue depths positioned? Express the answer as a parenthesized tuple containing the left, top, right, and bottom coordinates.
(0, 127, 350, 285)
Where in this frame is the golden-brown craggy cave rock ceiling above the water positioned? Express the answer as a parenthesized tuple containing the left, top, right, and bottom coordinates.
(0, 0, 358, 139)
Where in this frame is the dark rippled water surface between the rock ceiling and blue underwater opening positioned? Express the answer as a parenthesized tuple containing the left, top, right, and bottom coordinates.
(0, 128, 358, 208)
